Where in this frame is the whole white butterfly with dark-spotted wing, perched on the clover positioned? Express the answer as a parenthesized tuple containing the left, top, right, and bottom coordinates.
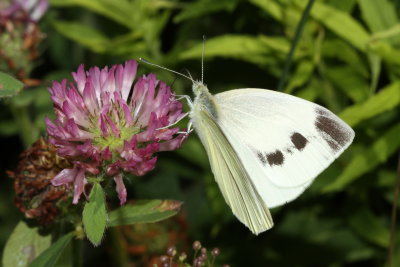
(142, 59, 354, 234)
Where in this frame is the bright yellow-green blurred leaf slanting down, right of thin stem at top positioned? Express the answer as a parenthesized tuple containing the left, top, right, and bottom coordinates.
(296, 0, 370, 51)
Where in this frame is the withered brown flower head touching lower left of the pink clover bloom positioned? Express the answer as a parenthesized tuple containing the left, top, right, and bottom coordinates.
(8, 138, 71, 225)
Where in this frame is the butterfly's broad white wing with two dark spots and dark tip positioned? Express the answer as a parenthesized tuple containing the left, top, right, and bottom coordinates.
(214, 89, 354, 207)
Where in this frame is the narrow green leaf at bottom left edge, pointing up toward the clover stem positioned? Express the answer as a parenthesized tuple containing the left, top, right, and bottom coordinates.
(29, 233, 73, 267)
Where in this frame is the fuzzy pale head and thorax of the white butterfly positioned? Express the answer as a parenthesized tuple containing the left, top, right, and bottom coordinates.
(190, 82, 218, 120)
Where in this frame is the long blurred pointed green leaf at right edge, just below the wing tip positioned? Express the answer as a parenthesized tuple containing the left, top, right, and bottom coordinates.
(322, 124, 400, 192)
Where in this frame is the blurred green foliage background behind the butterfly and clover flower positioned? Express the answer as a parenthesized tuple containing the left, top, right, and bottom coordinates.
(0, 0, 400, 266)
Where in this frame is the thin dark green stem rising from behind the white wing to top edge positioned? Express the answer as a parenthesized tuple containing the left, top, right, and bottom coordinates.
(278, 0, 315, 91)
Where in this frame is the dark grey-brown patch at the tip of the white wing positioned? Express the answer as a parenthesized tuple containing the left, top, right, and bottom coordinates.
(314, 108, 351, 151)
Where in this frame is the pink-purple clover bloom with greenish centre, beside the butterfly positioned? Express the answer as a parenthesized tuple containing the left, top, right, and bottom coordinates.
(46, 60, 186, 205)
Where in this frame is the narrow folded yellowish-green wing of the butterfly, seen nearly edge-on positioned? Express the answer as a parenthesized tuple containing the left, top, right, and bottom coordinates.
(192, 110, 273, 234)
